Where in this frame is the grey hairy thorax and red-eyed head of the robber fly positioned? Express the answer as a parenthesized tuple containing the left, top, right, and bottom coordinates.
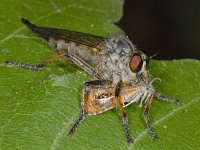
(101, 36, 147, 84)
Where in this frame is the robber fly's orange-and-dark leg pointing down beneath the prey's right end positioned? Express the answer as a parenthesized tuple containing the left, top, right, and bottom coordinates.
(144, 95, 158, 140)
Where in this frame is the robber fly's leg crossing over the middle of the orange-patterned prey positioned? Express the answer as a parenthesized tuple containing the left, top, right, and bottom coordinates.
(115, 82, 133, 143)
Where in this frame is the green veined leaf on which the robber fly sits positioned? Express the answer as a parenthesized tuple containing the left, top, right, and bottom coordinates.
(0, 0, 200, 150)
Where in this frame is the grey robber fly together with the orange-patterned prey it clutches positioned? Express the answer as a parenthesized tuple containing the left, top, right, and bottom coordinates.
(7, 18, 179, 142)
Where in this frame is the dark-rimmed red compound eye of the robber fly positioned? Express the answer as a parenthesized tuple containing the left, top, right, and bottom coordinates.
(130, 53, 143, 72)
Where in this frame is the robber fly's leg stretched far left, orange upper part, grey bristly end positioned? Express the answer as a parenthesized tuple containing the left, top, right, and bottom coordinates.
(6, 53, 66, 70)
